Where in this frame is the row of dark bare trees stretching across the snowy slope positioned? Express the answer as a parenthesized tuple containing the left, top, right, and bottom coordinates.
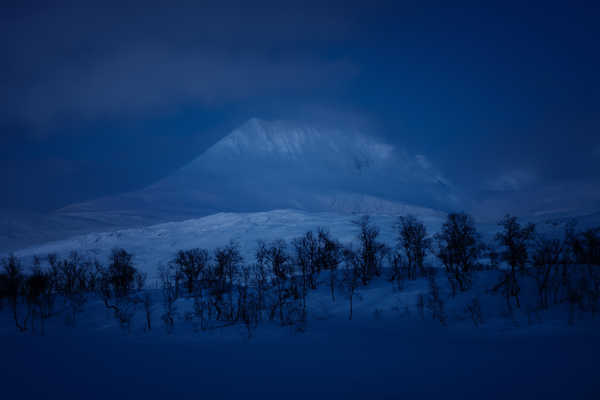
(0, 213, 600, 336)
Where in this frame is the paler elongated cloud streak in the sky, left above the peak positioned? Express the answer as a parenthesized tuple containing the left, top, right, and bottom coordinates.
(21, 47, 357, 124)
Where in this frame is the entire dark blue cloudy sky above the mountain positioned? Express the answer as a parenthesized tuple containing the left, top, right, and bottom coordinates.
(0, 1, 600, 210)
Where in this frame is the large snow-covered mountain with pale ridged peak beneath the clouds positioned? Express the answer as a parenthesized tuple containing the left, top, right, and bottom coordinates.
(0, 119, 460, 249)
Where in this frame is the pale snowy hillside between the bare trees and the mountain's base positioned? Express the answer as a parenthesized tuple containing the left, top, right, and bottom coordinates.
(15, 210, 443, 278)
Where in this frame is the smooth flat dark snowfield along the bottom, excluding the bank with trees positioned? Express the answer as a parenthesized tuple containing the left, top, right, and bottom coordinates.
(0, 320, 600, 399)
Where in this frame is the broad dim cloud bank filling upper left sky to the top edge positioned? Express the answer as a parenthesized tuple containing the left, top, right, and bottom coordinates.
(0, 1, 358, 133)
